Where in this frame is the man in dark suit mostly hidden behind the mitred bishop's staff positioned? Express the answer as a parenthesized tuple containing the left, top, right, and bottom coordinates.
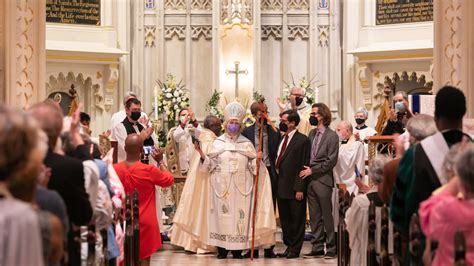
(242, 102, 280, 258)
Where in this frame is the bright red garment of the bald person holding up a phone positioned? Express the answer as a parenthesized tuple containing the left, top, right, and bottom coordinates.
(114, 161, 174, 259)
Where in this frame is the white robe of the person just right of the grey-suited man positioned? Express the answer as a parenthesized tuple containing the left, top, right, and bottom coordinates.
(333, 136, 365, 195)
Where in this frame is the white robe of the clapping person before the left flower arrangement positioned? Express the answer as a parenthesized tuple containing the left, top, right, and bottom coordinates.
(173, 124, 202, 173)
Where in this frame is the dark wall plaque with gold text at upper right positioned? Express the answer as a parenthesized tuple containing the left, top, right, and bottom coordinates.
(375, 0, 433, 25)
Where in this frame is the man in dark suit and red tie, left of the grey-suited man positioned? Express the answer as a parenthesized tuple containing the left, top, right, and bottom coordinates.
(276, 110, 311, 259)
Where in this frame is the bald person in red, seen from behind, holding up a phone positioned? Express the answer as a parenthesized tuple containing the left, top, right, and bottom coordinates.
(114, 134, 174, 265)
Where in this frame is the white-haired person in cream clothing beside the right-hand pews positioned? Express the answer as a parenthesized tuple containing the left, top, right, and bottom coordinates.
(345, 154, 389, 265)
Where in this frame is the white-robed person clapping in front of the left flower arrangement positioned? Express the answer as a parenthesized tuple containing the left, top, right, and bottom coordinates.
(173, 108, 202, 175)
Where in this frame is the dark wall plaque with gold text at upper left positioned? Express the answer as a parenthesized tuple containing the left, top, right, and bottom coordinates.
(46, 0, 101, 26)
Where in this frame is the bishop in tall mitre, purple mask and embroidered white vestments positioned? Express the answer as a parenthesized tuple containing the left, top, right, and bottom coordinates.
(201, 102, 276, 258)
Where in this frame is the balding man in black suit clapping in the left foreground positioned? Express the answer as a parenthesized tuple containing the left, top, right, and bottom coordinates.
(29, 102, 92, 265)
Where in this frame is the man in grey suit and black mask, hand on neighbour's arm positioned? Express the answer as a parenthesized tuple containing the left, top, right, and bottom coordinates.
(300, 103, 339, 259)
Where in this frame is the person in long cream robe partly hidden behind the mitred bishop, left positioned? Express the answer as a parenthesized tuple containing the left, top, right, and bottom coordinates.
(171, 116, 221, 253)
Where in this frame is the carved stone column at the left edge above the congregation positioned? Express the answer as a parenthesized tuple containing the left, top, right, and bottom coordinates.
(0, 0, 46, 108)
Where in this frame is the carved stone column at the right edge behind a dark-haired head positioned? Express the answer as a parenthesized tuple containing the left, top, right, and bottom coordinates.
(433, 0, 474, 118)
